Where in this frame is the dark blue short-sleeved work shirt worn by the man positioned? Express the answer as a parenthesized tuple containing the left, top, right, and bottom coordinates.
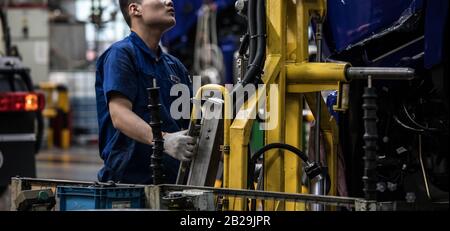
(95, 32, 192, 184)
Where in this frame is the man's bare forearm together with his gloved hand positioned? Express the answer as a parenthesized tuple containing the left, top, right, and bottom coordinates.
(109, 93, 195, 161)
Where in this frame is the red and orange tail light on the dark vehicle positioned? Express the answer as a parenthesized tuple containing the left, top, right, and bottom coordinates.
(0, 92, 45, 112)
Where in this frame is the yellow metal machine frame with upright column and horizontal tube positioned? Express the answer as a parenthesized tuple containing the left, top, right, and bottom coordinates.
(224, 0, 348, 211)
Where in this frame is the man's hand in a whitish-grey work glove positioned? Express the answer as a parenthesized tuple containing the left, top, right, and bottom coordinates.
(164, 131, 195, 162)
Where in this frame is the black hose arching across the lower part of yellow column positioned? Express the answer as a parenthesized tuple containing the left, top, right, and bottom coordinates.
(247, 143, 323, 189)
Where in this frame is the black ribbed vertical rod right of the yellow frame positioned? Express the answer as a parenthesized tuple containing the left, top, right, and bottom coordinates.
(363, 76, 378, 200)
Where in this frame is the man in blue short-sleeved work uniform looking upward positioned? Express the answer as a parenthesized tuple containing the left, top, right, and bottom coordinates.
(95, 0, 195, 184)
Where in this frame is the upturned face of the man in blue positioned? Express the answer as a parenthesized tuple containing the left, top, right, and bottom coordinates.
(134, 0, 176, 31)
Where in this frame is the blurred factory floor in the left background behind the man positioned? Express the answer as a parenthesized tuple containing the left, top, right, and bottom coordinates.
(0, 145, 103, 211)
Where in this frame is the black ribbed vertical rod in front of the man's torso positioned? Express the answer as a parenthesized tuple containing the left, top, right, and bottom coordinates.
(147, 79, 164, 185)
